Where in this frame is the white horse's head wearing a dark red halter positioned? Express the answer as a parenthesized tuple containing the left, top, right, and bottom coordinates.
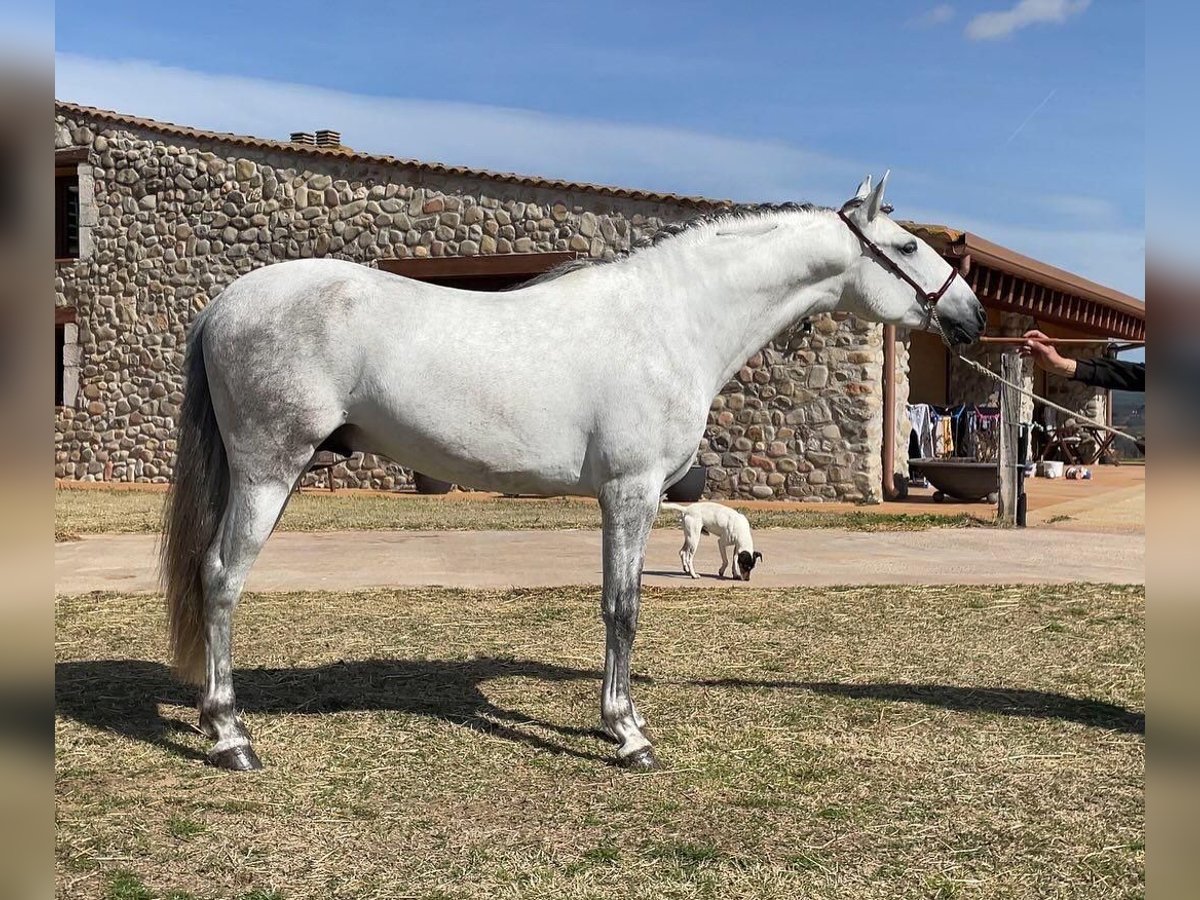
(838, 173, 986, 343)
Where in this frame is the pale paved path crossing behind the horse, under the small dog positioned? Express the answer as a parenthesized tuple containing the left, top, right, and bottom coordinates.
(54, 528, 1146, 594)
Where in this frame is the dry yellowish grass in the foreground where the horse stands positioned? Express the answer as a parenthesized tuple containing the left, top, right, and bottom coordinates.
(55, 584, 1145, 900)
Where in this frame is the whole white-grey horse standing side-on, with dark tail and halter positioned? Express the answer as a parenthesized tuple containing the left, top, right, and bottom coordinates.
(162, 175, 984, 769)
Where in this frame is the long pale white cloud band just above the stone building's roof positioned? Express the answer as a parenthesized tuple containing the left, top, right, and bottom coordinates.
(55, 54, 870, 203)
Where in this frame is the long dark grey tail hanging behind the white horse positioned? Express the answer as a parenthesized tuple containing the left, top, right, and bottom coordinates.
(160, 313, 229, 684)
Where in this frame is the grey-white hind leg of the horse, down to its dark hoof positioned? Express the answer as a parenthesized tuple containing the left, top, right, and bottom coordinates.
(200, 472, 295, 770)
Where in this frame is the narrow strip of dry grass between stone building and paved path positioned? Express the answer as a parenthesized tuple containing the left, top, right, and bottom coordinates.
(54, 488, 982, 541)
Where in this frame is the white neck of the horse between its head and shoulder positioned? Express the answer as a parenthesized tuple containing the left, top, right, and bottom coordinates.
(647, 214, 853, 394)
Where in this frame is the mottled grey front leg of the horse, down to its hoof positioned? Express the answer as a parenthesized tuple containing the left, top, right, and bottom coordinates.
(600, 479, 661, 769)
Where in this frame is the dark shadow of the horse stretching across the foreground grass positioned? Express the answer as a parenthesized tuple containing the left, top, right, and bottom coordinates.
(54, 658, 1146, 762)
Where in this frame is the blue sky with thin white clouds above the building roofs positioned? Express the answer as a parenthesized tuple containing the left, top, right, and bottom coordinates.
(55, 0, 1145, 298)
